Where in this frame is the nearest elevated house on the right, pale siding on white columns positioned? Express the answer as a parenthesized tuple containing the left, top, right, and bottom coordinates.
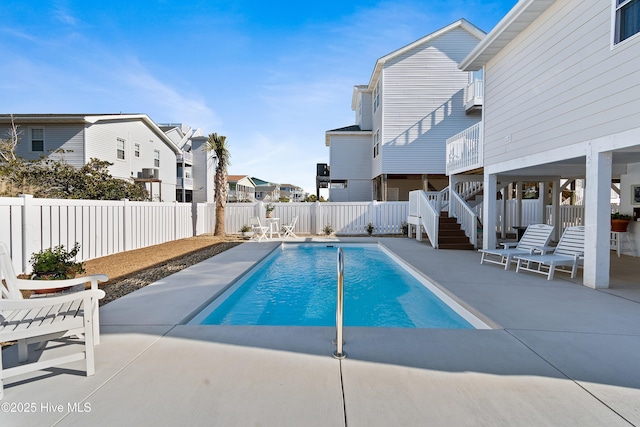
(456, 0, 640, 288)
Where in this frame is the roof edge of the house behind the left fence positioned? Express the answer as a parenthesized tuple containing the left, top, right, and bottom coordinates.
(0, 113, 181, 153)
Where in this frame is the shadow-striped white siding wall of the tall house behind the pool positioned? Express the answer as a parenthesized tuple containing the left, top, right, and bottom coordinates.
(374, 28, 480, 174)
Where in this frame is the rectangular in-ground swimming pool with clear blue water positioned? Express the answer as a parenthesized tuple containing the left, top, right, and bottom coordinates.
(189, 244, 488, 329)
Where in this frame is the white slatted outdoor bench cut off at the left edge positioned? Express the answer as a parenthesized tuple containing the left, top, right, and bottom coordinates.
(0, 243, 107, 399)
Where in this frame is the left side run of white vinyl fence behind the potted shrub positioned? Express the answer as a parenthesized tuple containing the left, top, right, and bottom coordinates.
(0, 195, 215, 272)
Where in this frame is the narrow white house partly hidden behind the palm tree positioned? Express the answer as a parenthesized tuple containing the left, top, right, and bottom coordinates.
(158, 123, 215, 203)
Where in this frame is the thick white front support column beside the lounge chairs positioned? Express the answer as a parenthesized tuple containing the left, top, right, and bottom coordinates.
(583, 147, 612, 289)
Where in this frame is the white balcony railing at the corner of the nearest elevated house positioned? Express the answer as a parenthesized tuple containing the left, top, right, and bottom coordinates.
(447, 122, 483, 175)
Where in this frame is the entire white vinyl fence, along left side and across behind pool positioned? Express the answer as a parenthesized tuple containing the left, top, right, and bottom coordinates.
(0, 195, 408, 272)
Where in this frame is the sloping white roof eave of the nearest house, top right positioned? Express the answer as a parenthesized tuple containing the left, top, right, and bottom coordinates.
(459, 0, 556, 71)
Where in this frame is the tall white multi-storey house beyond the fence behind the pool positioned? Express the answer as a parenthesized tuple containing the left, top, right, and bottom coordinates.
(325, 19, 485, 202)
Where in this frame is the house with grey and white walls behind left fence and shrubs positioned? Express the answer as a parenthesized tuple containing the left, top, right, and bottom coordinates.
(0, 114, 180, 201)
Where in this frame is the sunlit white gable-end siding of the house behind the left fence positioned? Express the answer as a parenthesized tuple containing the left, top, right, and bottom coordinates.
(86, 120, 176, 202)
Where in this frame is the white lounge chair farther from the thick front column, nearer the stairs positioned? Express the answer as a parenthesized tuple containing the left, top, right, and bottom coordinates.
(479, 224, 555, 270)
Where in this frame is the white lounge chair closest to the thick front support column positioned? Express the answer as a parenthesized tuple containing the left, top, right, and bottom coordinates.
(516, 226, 584, 280)
